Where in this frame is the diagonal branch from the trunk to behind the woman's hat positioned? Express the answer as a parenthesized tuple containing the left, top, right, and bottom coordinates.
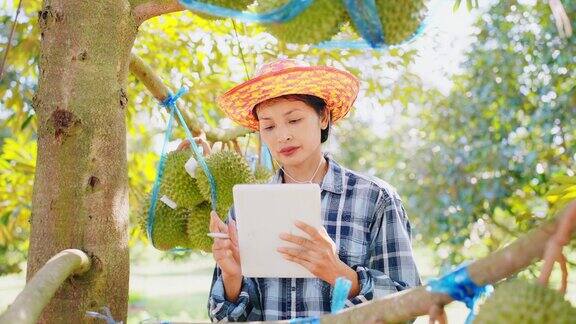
(130, 54, 251, 142)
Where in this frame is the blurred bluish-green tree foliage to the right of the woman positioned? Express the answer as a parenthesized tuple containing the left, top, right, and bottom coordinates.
(340, 1, 576, 265)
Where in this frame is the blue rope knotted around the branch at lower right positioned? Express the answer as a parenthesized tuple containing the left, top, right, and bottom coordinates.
(426, 265, 494, 324)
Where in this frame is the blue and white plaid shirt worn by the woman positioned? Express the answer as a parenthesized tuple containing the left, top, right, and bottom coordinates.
(208, 156, 420, 321)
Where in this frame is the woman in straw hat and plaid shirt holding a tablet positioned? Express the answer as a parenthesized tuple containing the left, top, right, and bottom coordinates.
(208, 59, 420, 321)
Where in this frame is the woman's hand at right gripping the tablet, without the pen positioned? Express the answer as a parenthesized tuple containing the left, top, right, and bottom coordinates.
(278, 221, 358, 286)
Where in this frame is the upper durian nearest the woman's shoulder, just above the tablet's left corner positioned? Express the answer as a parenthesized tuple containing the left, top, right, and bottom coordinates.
(196, 150, 255, 217)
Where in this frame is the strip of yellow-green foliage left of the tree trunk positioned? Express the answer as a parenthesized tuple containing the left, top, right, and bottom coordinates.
(0, 1, 40, 275)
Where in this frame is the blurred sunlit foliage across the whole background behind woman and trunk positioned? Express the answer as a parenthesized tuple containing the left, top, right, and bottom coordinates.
(0, 1, 576, 274)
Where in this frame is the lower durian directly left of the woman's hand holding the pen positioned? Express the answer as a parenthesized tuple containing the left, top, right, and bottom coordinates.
(187, 202, 214, 252)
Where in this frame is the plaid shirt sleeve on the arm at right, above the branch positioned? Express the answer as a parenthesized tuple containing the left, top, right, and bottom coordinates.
(346, 195, 421, 306)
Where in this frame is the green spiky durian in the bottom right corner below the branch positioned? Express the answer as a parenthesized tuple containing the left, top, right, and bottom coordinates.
(474, 279, 576, 324)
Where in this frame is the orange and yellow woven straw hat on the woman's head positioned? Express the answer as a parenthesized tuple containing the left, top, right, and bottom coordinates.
(218, 59, 360, 131)
